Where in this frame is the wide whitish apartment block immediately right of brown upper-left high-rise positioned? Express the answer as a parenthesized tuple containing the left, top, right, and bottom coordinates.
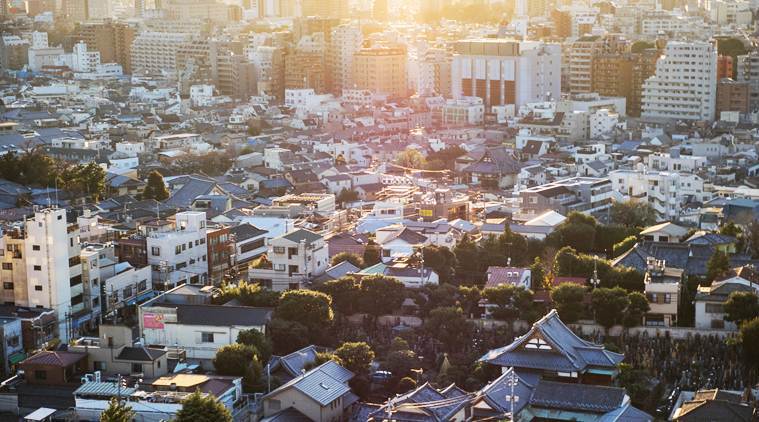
(131, 31, 190, 74)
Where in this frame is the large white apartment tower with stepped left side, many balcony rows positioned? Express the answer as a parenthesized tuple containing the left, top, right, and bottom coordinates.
(641, 41, 717, 121)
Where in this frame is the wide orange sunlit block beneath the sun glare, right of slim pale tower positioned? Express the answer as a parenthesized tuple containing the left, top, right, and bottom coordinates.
(353, 45, 408, 97)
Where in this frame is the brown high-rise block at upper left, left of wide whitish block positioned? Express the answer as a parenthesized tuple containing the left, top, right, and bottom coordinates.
(74, 20, 137, 74)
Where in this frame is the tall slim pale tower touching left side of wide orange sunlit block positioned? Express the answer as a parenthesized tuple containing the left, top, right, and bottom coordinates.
(326, 24, 364, 95)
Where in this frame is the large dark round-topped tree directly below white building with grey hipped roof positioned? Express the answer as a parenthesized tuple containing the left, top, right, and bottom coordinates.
(274, 290, 334, 342)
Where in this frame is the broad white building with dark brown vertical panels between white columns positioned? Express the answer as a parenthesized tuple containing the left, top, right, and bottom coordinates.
(451, 39, 561, 108)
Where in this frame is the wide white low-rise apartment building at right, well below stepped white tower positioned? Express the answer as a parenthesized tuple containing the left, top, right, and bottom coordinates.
(609, 168, 711, 220)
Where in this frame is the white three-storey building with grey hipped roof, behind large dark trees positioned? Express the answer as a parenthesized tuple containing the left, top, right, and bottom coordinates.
(248, 229, 329, 291)
